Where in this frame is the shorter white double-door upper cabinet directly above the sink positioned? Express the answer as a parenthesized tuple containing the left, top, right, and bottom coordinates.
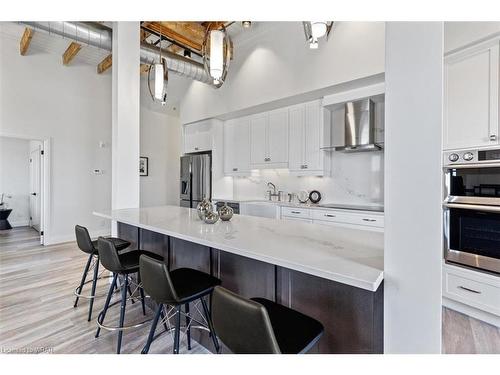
(250, 109, 288, 169)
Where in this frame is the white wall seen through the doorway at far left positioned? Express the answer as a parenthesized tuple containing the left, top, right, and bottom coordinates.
(0, 137, 30, 227)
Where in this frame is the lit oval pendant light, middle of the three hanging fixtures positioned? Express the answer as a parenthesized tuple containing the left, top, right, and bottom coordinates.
(202, 24, 232, 88)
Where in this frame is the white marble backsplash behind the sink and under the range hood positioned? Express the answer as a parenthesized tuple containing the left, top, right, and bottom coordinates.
(233, 151, 384, 205)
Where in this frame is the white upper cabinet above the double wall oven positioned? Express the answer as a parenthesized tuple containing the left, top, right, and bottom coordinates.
(443, 39, 500, 150)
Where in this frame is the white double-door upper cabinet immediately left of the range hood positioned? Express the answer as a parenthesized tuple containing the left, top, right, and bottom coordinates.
(289, 100, 324, 176)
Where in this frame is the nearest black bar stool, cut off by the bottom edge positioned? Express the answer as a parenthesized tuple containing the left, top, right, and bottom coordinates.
(212, 287, 324, 354)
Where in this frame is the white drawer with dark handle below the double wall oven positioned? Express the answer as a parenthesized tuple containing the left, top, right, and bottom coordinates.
(443, 268, 500, 315)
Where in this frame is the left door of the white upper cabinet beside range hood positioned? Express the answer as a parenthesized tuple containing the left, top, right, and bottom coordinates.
(288, 104, 305, 171)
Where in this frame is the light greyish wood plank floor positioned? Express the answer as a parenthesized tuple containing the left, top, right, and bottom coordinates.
(0, 228, 500, 353)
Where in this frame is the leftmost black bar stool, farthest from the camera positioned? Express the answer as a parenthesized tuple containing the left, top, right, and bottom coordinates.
(73, 225, 130, 322)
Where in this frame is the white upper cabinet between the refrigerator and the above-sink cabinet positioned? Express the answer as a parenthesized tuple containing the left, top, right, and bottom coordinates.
(224, 117, 250, 176)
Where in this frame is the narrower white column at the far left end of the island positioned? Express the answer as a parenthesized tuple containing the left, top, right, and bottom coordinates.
(111, 22, 140, 210)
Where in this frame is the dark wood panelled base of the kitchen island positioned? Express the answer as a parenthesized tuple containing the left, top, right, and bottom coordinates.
(118, 223, 384, 354)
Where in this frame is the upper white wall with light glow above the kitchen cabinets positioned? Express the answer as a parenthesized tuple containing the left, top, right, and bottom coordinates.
(181, 22, 384, 124)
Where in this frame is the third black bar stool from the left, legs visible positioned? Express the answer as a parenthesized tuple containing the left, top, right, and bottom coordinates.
(139, 255, 220, 354)
